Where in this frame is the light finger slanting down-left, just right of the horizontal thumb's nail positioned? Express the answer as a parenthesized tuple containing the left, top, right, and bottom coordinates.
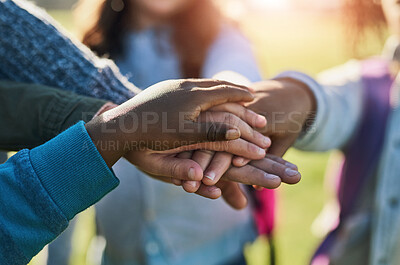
(203, 152, 232, 186)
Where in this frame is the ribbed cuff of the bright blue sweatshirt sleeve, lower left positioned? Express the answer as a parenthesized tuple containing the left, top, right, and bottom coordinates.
(30, 122, 119, 220)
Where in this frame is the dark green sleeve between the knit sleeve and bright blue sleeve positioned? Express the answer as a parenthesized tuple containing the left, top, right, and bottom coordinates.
(0, 80, 107, 151)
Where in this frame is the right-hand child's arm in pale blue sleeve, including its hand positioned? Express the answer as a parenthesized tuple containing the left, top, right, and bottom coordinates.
(248, 62, 363, 155)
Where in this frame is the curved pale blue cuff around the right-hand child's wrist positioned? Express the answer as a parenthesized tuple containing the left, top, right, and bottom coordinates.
(274, 71, 327, 149)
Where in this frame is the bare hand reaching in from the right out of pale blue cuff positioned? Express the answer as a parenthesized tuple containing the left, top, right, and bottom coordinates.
(245, 79, 316, 157)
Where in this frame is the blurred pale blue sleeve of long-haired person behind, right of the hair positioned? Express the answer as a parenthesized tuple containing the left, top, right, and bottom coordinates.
(202, 24, 262, 82)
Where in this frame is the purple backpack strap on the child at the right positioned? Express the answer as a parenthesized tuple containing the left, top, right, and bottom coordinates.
(311, 59, 393, 265)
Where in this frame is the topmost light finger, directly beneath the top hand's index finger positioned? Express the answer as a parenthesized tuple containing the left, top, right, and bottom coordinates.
(209, 103, 267, 128)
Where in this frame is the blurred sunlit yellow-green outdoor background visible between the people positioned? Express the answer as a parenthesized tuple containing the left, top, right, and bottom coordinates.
(27, 0, 382, 265)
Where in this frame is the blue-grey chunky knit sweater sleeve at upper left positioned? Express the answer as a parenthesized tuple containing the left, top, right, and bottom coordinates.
(0, 0, 139, 104)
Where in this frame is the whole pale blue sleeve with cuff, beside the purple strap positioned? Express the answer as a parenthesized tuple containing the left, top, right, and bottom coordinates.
(281, 60, 364, 151)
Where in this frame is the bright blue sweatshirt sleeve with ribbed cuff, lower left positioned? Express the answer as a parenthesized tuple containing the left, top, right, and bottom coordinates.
(0, 122, 119, 265)
